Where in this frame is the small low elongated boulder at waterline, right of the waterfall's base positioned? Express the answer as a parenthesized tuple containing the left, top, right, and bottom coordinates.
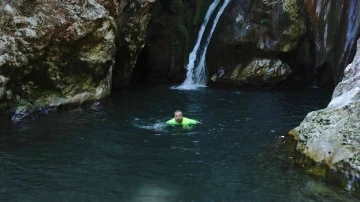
(211, 59, 292, 85)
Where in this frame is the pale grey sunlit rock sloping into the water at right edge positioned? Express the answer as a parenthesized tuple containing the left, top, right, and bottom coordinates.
(287, 40, 360, 191)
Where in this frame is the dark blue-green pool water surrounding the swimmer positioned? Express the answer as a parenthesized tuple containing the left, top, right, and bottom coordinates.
(0, 86, 358, 202)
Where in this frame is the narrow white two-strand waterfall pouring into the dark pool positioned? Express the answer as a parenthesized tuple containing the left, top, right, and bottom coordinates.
(178, 0, 230, 89)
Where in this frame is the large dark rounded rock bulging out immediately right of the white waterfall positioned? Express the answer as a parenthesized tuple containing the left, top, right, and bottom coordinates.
(207, 0, 307, 84)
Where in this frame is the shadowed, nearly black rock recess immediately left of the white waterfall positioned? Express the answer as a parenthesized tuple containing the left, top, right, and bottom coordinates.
(136, 0, 213, 83)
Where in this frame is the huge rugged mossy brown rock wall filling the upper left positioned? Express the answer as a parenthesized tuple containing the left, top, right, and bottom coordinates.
(0, 0, 155, 119)
